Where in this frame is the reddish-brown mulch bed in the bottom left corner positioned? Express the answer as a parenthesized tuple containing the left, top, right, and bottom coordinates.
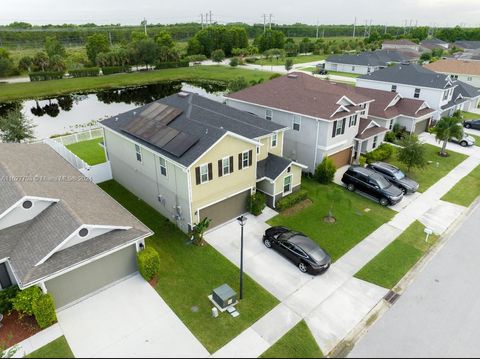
(0, 311, 41, 348)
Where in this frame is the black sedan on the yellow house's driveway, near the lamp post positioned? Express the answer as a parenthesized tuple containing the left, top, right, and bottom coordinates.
(263, 227, 332, 274)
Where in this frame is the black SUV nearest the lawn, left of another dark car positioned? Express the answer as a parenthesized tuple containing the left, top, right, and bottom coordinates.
(342, 166, 403, 206)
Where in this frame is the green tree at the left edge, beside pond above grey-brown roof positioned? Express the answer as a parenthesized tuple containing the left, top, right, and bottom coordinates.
(0, 106, 35, 142)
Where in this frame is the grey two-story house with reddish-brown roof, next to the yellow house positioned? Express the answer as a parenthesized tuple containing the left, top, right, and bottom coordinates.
(227, 73, 378, 172)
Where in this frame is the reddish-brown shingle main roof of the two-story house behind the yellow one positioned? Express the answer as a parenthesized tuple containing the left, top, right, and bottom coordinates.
(226, 72, 371, 120)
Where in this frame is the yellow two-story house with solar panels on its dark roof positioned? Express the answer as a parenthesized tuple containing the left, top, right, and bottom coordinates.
(101, 92, 304, 232)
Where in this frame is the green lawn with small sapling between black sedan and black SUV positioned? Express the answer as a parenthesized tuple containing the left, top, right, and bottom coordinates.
(268, 178, 395, 261)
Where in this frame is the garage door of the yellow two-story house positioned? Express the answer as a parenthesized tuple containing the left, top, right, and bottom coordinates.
(200, 190, 250, 228)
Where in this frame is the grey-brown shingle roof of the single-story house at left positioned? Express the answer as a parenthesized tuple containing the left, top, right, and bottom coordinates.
(0, 143, 152, 286)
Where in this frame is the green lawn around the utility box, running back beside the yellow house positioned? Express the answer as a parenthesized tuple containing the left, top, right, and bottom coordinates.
(100, 181, 278, 353)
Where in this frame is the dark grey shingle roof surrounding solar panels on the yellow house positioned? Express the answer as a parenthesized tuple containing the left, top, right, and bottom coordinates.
(101, 93, 285, 167)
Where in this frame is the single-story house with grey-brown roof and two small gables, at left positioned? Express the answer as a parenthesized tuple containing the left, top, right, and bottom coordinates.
(0, 143, 152, 308)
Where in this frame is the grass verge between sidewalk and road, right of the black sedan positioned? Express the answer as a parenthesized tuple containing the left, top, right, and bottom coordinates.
(355, 221, 438, 289)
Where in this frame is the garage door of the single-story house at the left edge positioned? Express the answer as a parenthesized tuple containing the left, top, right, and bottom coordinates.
(45, 245, 137, 308)
